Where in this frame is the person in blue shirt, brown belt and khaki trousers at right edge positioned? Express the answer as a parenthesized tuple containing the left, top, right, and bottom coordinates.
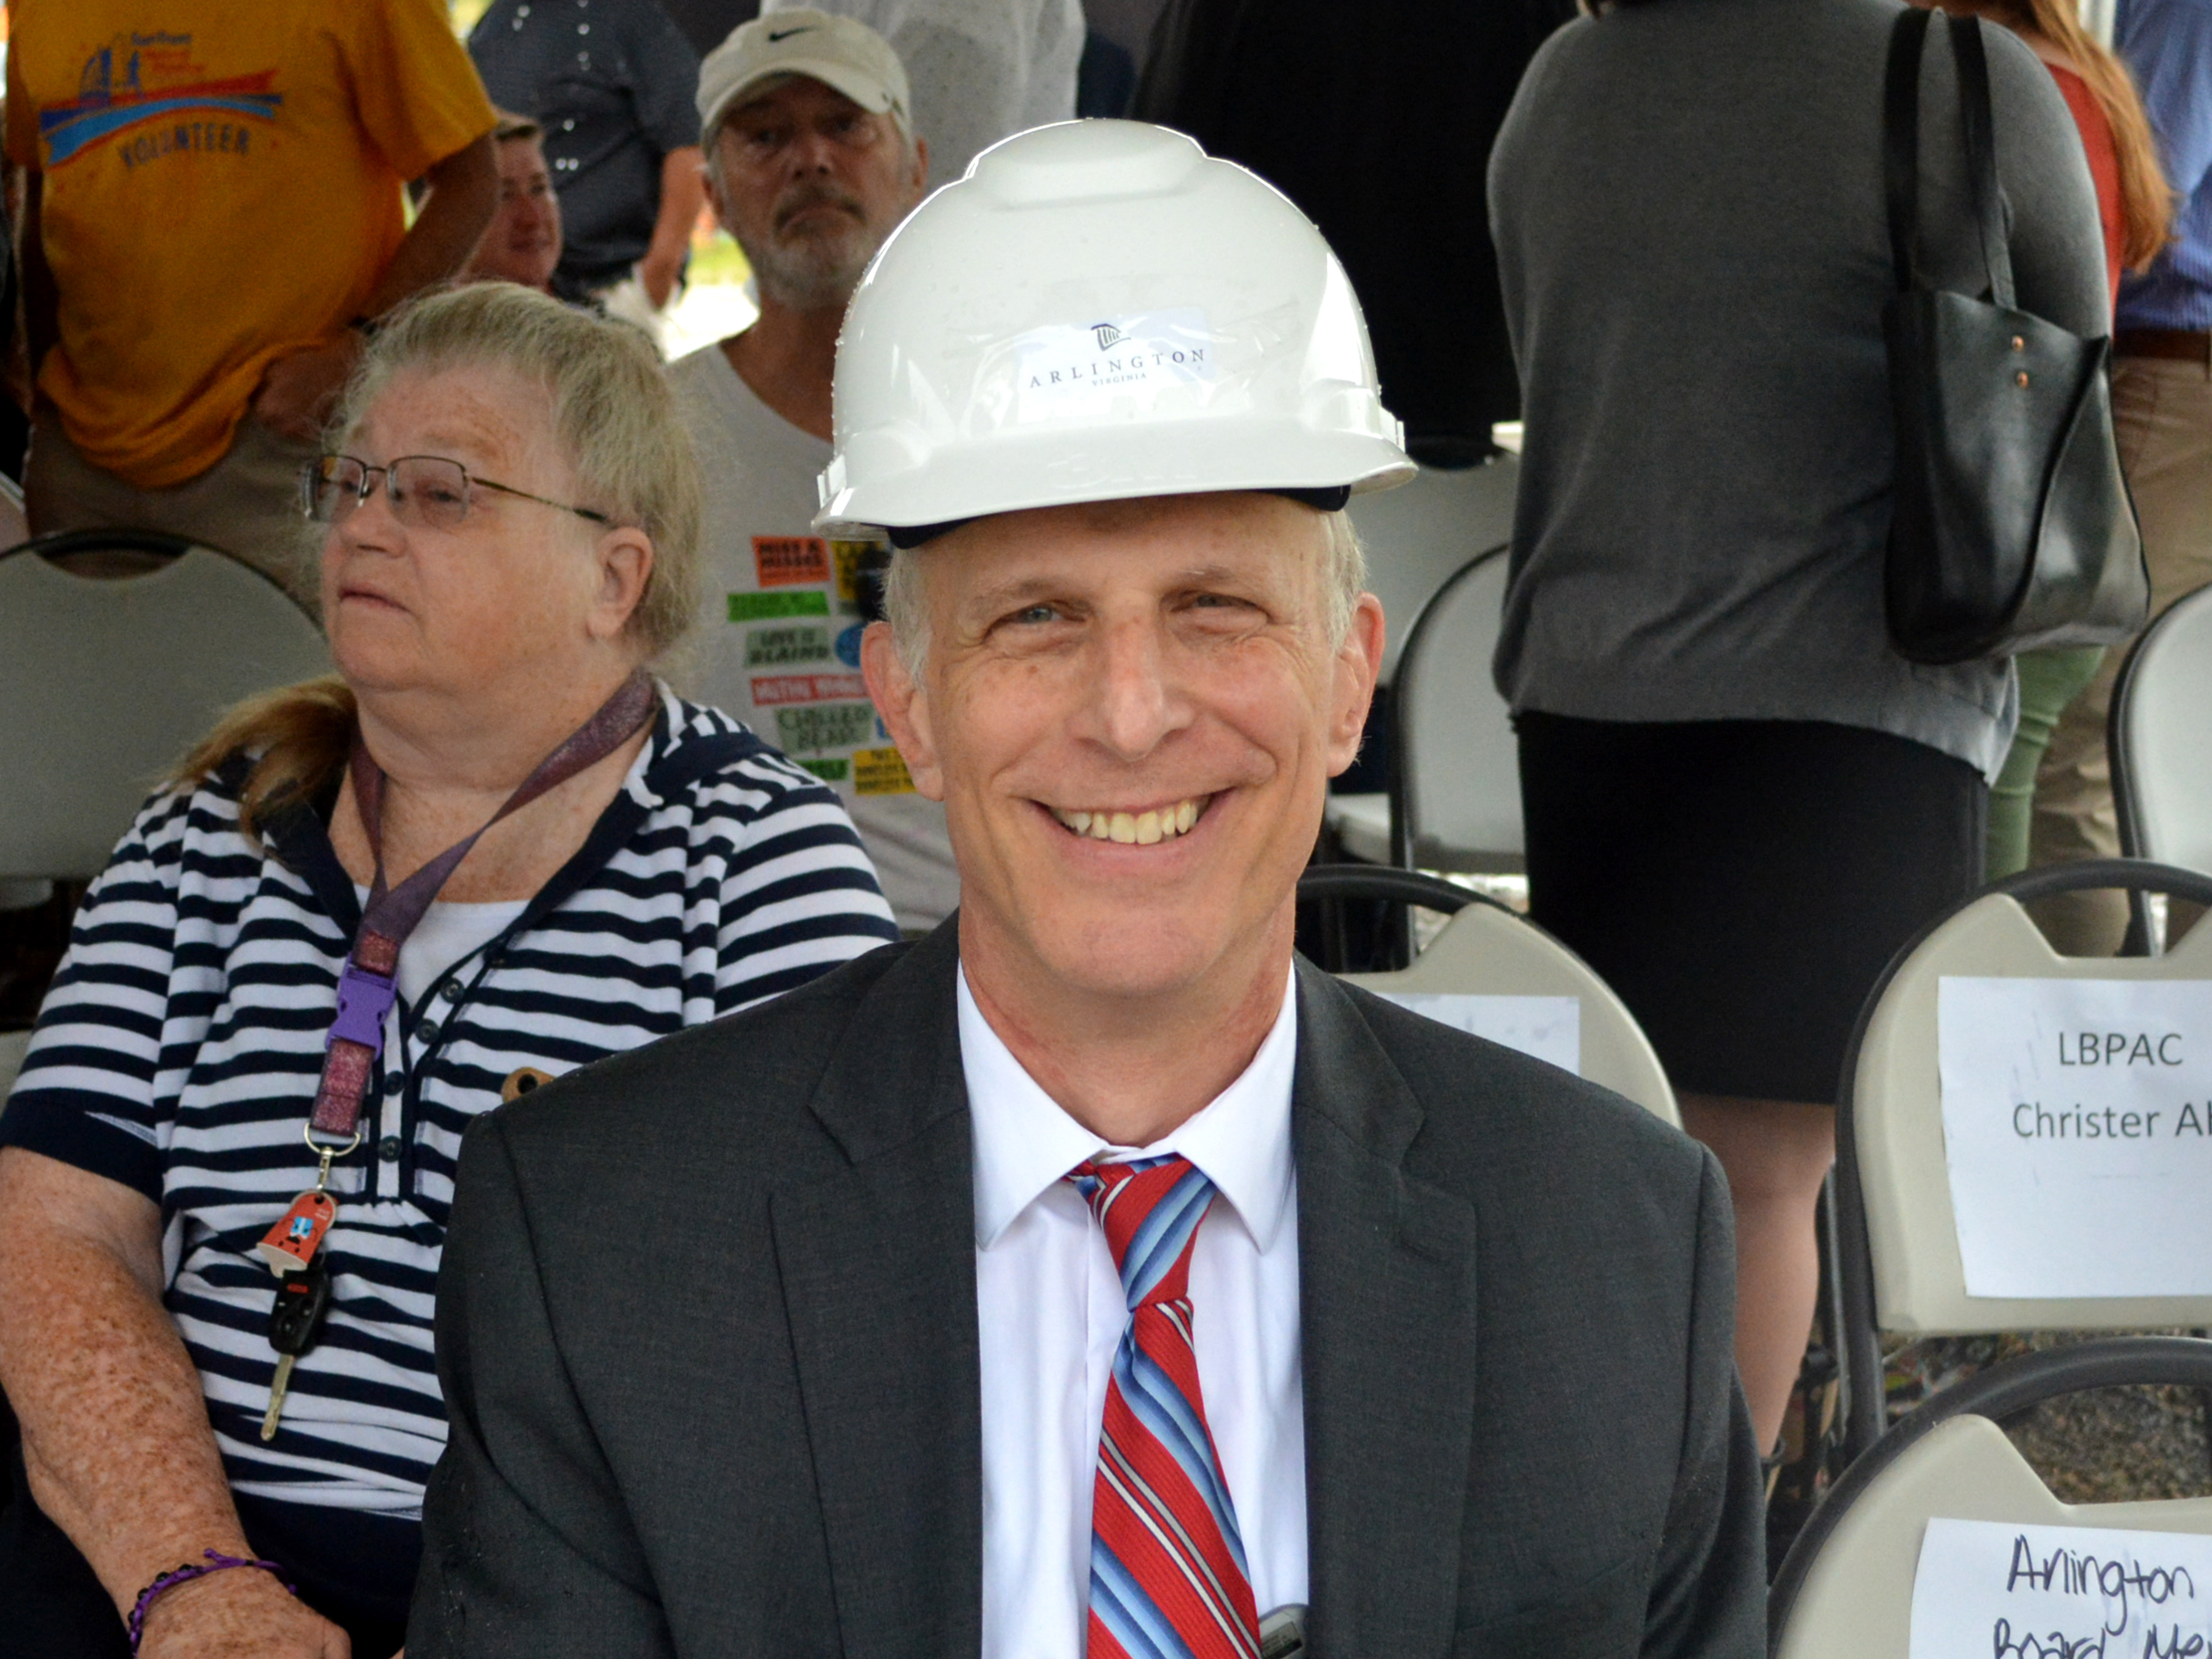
(2031, 0, 2212, 956)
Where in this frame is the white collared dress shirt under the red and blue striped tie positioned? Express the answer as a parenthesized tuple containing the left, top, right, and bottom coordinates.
(960, 971, 1305, 1659)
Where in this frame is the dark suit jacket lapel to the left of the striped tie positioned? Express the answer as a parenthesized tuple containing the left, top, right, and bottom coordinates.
(772, 922, 982, 1659)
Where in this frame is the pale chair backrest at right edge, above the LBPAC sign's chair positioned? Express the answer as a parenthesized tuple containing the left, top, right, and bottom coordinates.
(2110, 588, 2212, 871)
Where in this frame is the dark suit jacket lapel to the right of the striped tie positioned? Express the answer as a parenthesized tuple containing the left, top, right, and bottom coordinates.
(1292, 960, 1475, 1654)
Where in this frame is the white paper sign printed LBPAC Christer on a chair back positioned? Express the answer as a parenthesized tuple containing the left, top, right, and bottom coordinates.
(1936, 976, 2212, 1296)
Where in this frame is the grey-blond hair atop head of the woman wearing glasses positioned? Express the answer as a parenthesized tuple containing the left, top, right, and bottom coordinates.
(332, 283, 701, 659)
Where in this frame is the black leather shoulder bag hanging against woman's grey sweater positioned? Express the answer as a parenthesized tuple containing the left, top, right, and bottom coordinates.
(1883, 6, 2150, 664)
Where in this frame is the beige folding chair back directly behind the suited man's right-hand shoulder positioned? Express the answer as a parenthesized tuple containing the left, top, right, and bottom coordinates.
(1299, 865, 1681, 1128)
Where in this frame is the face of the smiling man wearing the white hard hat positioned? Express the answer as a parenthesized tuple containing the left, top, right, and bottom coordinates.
(865, 493, 1382, 998)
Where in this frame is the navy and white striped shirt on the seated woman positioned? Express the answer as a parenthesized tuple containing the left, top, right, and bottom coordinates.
(0, 690, 898, 1517)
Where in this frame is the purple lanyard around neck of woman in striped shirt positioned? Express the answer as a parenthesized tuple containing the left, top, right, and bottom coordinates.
(307, 668, 659, 1168)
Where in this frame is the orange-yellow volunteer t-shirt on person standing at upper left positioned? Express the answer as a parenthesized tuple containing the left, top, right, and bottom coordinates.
(6, 0, 493, 488)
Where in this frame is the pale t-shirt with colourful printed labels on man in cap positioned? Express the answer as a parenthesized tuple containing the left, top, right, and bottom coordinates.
(668, 345, 960, 929)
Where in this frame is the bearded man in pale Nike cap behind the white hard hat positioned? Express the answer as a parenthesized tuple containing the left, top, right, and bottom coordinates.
(672, 11, 960, 929)
